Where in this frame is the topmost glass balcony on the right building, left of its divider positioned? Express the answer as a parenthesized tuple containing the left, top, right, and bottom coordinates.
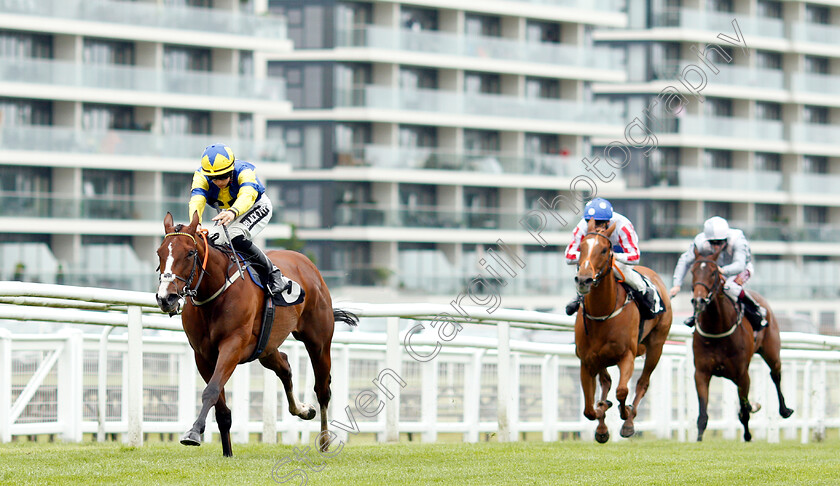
(651, 8, 788, 38)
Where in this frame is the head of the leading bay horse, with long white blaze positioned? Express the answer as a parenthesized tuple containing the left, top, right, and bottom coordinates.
(155, 213, 201, 315)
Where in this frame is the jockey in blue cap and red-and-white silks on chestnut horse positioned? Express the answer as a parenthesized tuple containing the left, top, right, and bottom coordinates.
(566, 197, 655, 315)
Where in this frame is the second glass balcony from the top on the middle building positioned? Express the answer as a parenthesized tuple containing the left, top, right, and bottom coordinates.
(335, 85, 622, 125)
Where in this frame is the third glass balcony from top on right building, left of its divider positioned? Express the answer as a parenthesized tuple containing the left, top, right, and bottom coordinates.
(664, 115, 785, 141)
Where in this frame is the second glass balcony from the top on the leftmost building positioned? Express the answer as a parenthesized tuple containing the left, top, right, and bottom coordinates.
(0, 58, 286, 101)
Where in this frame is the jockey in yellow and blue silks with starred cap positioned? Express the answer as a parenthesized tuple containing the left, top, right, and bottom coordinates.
(189, 143, 304, 305)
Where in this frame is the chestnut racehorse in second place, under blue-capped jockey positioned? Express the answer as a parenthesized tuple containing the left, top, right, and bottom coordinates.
(575, 219, 671, 444)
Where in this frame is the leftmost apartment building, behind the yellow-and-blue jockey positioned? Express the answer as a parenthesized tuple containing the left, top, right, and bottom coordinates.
(0, 0, 292, 290)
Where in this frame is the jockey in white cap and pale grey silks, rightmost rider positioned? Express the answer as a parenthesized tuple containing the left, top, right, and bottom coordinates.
(669, 216, 767, 331)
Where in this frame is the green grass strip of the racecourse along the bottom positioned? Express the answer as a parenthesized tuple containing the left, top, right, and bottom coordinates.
(0, 439, 840, 486)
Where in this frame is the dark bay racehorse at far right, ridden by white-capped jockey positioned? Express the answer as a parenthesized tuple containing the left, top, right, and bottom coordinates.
(691, 247, 793, 442)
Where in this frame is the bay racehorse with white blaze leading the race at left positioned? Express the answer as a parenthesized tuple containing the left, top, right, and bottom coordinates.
(156, 213, 358, 457)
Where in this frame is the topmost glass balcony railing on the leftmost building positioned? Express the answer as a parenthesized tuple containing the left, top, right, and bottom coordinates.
(0, 0, 287, 39)
